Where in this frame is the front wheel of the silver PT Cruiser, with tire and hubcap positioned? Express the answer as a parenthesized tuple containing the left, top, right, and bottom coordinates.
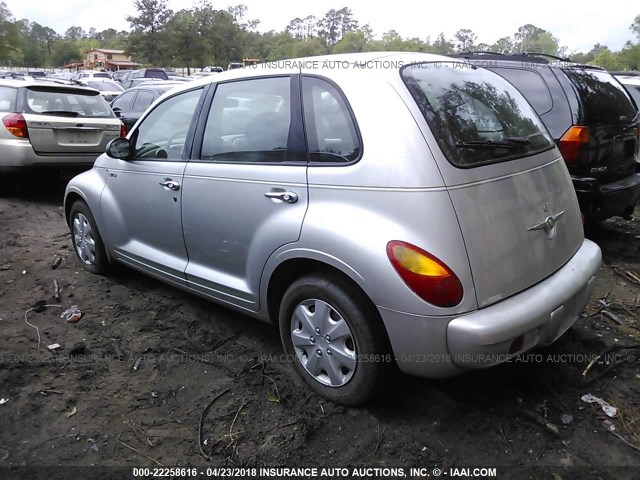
(69, 200, 109, 274)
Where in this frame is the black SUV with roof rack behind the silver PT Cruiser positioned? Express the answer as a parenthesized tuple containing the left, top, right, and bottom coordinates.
(457, 52, 640, 222)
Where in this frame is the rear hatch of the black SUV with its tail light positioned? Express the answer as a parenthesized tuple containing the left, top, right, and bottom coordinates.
(559, 68, 639, 183)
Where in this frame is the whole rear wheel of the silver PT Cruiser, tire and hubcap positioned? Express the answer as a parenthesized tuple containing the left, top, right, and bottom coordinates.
(279, 275, 395, 405)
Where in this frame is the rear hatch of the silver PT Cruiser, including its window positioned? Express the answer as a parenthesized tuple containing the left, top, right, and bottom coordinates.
(402, 62, 583, 307)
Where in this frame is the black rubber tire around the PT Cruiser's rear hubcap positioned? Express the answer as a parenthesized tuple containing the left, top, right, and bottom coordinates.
(279, 274, 396, 406)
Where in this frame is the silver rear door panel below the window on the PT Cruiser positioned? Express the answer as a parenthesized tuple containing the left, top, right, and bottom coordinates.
(182, 163, 307, 311)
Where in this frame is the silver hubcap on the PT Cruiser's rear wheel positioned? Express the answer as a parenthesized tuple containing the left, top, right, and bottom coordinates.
(291, 299, 356, 387)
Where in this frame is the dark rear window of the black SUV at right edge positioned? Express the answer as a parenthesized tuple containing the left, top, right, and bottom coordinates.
(564, 69, 636, 125)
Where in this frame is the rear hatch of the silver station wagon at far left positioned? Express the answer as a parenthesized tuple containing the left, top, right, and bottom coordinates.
(23, 86, 120, 155)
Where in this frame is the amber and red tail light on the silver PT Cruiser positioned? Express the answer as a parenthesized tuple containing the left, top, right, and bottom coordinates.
(387, 240, 463, 307)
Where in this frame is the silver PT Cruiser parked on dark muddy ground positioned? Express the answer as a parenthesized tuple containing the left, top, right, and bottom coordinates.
(65, 53, 601, 405)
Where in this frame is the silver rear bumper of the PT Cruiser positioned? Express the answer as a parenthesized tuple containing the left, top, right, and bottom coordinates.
(379, 240, 602, 377)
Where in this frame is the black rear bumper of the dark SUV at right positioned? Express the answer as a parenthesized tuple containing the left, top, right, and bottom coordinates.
(572, 172, 640, 221)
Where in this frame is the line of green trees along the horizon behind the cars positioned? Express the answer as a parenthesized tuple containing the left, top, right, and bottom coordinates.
(0, 0, 640, 70)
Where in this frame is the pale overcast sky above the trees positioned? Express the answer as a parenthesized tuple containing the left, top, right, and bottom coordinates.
(4, 0, 640, 52)
